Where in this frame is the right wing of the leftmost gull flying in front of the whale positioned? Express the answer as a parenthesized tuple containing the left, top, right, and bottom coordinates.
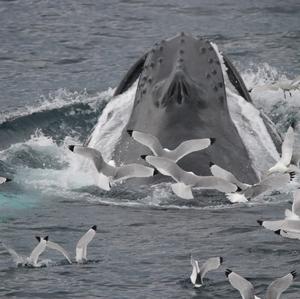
(113, 164, 154, 181)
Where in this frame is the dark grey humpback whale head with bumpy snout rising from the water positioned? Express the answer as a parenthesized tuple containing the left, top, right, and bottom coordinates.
(85, 32, 282, 184)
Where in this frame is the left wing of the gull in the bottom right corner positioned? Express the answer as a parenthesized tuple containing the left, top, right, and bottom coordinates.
(225, 269, 255, 299)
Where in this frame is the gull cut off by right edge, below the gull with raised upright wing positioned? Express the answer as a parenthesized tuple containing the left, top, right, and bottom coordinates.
(257, 189, 300, 233)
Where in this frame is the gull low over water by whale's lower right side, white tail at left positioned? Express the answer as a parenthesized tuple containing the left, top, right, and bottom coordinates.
(210, 162, 295, 203)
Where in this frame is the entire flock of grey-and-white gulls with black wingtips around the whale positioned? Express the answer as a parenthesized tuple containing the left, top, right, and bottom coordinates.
(0, 80, 300, 299)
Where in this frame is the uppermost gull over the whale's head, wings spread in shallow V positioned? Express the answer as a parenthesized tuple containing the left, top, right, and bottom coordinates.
(127, 130, 216, 162)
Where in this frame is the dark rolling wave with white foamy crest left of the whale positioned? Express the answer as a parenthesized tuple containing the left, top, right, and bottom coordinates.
(0, 88, 113, 149)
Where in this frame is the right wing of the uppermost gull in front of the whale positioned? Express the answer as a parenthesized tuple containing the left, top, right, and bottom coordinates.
(170, 138, 214, 162)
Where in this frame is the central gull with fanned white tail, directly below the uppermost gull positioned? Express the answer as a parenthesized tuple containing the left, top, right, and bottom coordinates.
(145, 156, 237, 199)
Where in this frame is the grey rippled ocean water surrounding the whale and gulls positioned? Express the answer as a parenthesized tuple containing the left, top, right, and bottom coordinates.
(0, 0, 300, 299)
